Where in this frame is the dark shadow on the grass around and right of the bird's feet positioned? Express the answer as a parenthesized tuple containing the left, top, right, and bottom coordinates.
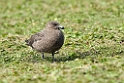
(23, 49, 97, 63)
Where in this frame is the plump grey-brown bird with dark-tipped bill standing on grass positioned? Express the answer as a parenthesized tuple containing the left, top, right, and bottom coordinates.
(25, 21, 65, 61)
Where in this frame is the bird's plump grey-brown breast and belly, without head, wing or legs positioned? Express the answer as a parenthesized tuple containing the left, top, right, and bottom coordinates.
(32, 30, 64, 53)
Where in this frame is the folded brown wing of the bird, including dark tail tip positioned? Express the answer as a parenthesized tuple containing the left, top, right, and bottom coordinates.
(25, 31, 44, 48)
